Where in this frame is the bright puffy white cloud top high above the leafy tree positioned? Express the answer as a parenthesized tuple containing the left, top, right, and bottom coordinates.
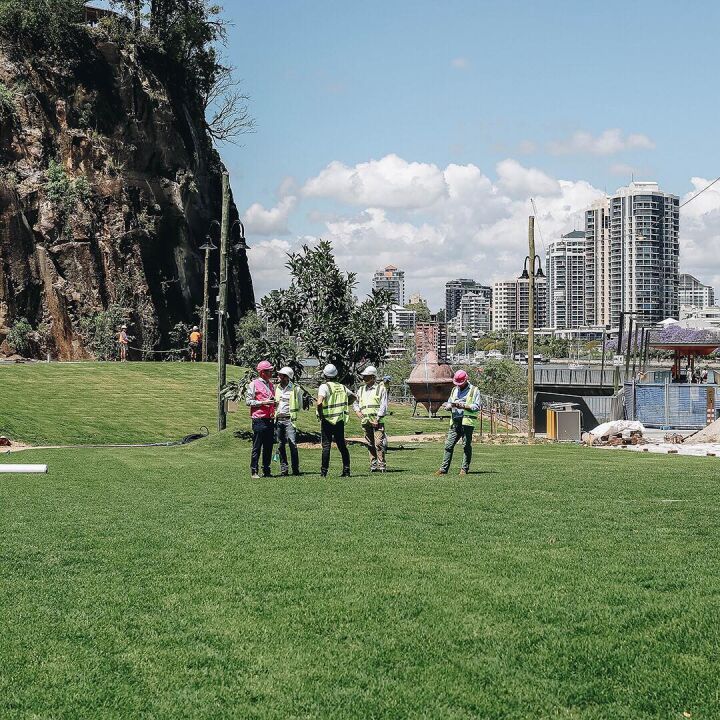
(303, 155, 447, 208)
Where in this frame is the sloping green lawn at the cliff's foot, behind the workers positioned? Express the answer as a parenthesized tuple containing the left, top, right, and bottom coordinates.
(0, 362, 466, 445)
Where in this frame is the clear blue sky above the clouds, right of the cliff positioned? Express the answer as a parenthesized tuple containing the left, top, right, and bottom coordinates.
(225, 0, 720, 202)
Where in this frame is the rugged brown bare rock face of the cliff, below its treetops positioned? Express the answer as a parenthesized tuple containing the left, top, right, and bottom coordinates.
(0, 29, 254, 359)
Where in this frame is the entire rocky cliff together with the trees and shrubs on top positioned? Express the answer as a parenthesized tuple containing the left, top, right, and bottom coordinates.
(0, 0, 254, 358)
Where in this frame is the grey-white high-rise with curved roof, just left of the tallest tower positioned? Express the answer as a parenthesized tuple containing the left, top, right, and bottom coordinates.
(546, 230, 595, 330)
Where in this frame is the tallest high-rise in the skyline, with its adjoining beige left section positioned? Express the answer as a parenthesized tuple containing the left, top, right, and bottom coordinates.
(585, 182, 679, 326)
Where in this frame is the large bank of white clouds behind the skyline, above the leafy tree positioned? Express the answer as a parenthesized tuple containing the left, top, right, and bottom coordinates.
(250, 155, 602, 307)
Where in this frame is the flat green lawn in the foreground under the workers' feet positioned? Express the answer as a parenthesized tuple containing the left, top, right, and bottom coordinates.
(0, 368, 720, 719)
